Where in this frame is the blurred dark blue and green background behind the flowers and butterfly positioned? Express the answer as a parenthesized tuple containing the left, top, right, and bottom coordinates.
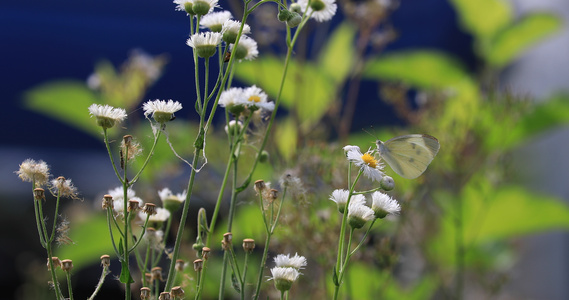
(0, 0, 569, 299)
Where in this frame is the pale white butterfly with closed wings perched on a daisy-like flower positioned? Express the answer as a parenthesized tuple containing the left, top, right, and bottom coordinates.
(375, 134, 441, 179)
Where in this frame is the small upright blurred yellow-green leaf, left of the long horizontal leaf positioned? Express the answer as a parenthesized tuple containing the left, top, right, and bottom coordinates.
(319, 22, 356, 84)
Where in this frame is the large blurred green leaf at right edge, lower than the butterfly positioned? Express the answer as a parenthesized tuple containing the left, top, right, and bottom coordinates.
(429, 177, 569, 265)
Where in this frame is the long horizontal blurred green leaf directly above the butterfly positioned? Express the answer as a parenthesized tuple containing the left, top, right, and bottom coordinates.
(363, 50, 474, 89)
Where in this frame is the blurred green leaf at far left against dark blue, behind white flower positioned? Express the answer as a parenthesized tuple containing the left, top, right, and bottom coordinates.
(24, 80, 101, 137)
